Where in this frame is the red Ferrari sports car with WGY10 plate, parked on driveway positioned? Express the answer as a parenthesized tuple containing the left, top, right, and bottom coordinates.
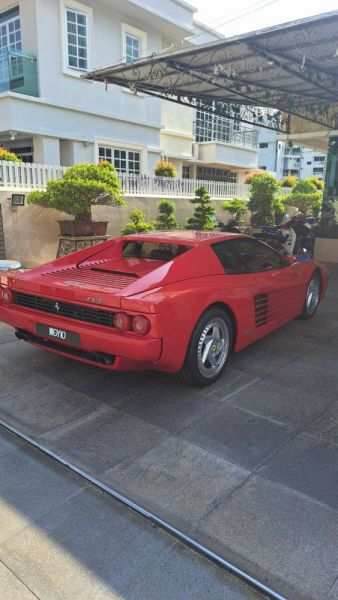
(0, 231, 328, 386)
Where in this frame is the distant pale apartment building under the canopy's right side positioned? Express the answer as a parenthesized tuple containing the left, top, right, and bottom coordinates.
(258, 128, 326, 179)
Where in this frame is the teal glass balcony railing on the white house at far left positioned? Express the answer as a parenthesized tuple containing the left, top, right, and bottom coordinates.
(0, 48, 39, 96)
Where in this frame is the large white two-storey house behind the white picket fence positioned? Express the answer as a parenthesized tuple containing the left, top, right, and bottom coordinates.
(0, 0, 257, 181)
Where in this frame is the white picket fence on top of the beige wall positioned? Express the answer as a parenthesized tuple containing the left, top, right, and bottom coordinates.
(0, 161, 290, 200)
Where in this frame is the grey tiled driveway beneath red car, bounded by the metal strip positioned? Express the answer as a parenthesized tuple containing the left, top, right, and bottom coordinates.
(0, 266, 338, 600)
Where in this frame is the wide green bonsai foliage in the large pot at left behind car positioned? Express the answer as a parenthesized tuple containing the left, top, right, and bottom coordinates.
(28, 161, 125, 222)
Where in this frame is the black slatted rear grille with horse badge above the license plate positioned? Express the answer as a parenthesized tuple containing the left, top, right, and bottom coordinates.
(13, 292, 115, 327)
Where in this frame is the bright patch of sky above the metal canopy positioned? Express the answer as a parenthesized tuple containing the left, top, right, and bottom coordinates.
(189, 0, 338, 36)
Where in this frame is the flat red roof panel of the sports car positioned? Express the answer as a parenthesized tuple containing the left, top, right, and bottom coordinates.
(123, 229, 245, 246)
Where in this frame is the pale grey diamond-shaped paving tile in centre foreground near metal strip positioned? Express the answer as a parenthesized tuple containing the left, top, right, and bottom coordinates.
(102, 437, 249, 531)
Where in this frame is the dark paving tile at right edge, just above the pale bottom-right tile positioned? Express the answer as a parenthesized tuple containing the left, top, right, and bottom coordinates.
(259, 434, 338, 508)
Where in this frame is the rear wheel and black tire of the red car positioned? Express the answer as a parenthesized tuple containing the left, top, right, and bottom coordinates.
(178, 306, 234, 387)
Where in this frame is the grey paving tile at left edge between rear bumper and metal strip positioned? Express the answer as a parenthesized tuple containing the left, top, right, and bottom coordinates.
(0, 360, 102, 435)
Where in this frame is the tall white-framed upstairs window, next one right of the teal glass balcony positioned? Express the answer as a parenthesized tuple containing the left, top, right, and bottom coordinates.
(66, 8, 88, 71)
